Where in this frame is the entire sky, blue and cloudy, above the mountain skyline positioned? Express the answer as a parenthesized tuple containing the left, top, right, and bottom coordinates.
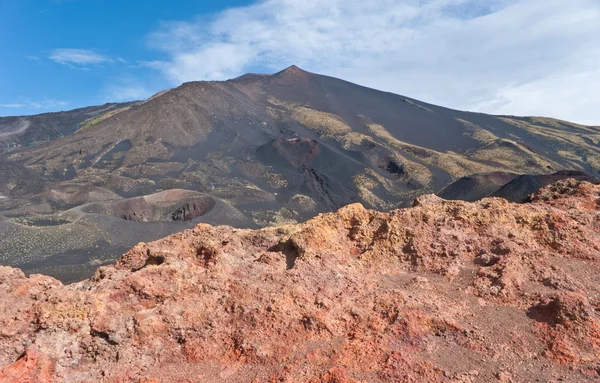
(0, 0, 600, 125)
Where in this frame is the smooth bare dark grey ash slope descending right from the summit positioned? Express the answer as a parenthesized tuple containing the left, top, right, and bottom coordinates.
(259, 67, 478, 152)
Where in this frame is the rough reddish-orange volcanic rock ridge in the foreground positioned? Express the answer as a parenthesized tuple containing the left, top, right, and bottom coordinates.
(0, 180, 600, 383)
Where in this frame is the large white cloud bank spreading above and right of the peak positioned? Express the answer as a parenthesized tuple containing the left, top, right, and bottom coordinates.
(147, 0, 600, 124)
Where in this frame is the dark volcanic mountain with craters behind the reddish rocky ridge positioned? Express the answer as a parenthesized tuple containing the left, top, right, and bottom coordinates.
(0, 66, 600, 279)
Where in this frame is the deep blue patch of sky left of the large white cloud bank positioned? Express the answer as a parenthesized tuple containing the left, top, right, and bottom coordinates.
(0, 0, 248, 115)
